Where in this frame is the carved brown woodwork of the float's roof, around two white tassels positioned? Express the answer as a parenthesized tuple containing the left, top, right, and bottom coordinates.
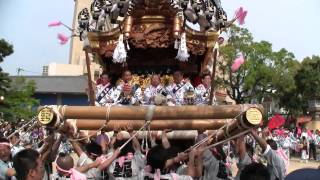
(88, 0, 222, 57)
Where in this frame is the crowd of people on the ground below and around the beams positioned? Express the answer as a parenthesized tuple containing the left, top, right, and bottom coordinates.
(0, 119, 319, 180)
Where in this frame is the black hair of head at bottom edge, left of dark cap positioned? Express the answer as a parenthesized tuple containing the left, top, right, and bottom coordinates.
(240, 163, 270, 180)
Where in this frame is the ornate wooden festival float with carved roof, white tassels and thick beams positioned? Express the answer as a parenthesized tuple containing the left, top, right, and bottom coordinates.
(38, 0, 263, 143)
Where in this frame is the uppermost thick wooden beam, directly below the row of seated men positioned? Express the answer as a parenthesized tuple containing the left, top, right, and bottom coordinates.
(53, 104, 263, 120)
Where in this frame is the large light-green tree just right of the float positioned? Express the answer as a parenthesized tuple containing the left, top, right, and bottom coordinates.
(218, 26, 299, 104)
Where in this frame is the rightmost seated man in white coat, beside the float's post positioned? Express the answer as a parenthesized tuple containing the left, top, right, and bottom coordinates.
(195, 74, 215, 104)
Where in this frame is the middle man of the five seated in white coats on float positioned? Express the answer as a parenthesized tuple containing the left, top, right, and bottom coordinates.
(144, 74, 163, 105)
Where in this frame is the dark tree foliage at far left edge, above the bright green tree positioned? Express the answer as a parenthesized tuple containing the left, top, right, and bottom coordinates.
(0, 39, 13, 96)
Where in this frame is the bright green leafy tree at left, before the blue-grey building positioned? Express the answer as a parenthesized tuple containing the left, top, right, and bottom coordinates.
(0, 77, 39, 121)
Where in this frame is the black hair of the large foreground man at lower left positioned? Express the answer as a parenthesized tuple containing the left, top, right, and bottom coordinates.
(13, 149, 40, 180)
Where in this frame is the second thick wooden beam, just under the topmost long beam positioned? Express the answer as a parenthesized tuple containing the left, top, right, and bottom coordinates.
(76, 119, 227, 131)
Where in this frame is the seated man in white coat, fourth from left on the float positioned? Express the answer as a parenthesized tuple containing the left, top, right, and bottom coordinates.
(166, 70, 194, 105)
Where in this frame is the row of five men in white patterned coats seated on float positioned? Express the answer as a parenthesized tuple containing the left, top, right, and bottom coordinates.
(96, 70, 216, 106)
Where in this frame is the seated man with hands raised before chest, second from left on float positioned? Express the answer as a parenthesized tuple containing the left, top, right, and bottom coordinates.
(117, 70, 142, 105)
